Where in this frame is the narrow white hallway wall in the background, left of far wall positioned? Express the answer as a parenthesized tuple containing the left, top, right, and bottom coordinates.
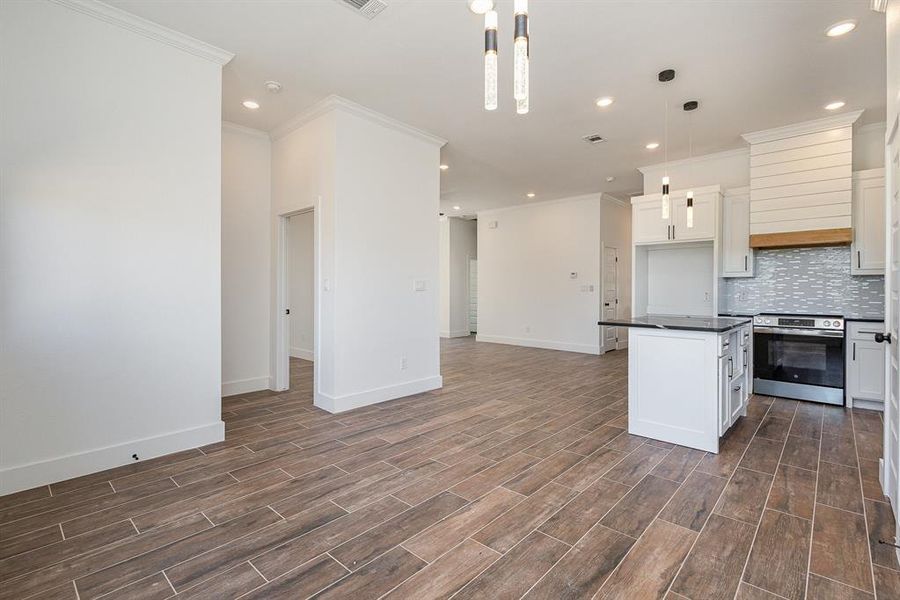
(440, 217, 478, 337)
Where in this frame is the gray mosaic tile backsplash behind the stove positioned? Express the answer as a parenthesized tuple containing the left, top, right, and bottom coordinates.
(720, 246, 884, 316)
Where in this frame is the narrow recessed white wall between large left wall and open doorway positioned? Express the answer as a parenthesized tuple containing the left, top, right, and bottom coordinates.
(222, 123, 272, 396)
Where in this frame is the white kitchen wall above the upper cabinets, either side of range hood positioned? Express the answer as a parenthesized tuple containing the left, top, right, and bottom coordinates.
(639, 123, 885, 194)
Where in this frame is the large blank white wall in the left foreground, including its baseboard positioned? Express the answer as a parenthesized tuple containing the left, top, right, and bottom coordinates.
(0, 2, 227, 494)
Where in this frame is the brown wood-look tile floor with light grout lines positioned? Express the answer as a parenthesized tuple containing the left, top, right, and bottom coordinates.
(0, 339, 900, 600)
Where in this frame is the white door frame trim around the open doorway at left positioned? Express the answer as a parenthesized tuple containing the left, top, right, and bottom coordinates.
(272, 203, 322, 397)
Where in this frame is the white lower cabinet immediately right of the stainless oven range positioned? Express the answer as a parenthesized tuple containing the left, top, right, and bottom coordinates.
(845, 321, 884, 410)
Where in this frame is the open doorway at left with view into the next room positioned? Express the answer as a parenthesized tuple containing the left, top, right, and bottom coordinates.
(273, 208, 320, 400)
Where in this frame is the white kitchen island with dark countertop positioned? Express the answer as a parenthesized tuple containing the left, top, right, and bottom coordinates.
(599, 316, 753, 453)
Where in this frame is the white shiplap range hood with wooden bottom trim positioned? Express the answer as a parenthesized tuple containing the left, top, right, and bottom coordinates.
(743, 110, 862, 248)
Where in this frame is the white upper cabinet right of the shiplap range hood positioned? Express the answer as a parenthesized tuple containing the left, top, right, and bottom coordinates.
(850, 169, 885, 275)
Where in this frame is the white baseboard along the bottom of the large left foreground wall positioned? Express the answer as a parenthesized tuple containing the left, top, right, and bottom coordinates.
(0, 421, 225, 496)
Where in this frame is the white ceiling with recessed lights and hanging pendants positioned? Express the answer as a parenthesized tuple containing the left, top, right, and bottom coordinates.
(109, 0, 885, 214)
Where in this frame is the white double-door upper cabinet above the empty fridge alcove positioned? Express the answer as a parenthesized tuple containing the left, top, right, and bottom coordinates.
(631, 185, 721, 244)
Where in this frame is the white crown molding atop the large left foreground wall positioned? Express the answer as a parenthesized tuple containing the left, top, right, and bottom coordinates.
(51, 0, 234, 66)
